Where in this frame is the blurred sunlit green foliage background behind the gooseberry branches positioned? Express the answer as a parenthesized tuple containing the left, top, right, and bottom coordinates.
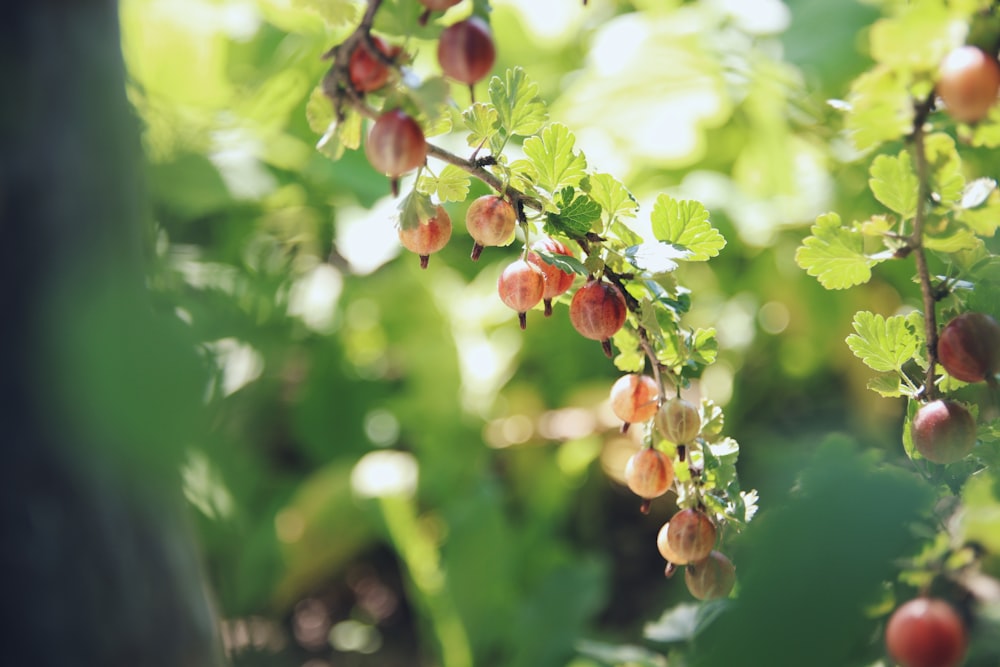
(109, 0, 998, 667)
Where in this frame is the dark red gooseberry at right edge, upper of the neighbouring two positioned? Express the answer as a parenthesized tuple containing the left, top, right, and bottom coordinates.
(937, 313, 1000, 382)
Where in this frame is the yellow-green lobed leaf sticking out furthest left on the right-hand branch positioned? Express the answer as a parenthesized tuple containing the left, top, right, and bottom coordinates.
(795, 213, 881, 289)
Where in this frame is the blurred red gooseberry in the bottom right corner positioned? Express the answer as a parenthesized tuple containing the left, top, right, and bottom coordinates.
(885, 597, 968, 667)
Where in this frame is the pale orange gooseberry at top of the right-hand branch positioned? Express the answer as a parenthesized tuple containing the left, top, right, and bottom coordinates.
(936, 45, 1000, 123)
